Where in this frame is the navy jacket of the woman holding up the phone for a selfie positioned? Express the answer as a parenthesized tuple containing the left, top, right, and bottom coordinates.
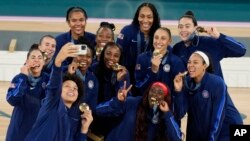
(25, 66, 86, 141)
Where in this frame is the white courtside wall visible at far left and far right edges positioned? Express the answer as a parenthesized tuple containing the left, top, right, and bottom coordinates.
(0, 51, 250, 87)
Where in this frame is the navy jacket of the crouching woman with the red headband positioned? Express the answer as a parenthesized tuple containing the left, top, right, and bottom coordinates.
(96, 96, 182, 141)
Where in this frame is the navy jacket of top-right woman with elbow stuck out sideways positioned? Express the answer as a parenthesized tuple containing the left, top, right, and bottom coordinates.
(173, 34, 246, 78)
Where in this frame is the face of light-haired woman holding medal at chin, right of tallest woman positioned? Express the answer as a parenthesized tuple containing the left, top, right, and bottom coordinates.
(153, 28, 172, 54)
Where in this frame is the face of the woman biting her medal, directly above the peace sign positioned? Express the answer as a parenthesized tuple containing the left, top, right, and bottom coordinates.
(104, 46, 121, 69)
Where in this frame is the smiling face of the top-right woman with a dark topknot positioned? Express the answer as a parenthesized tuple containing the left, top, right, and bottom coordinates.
(178, 17, 196, 42)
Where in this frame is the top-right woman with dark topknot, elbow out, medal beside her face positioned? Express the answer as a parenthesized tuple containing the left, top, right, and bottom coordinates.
(173, 11, 246, 78)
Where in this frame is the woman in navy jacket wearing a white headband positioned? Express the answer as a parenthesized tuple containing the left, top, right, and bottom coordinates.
(174, 51, 243, 141)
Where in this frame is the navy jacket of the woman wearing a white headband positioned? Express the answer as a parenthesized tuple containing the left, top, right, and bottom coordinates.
(176, 73, 243, 141)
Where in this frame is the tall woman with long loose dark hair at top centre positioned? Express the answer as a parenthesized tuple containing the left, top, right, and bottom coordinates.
(116, 3, 161, 92)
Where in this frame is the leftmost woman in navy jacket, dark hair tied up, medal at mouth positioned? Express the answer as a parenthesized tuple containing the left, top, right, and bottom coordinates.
(6, 45, 49, 141)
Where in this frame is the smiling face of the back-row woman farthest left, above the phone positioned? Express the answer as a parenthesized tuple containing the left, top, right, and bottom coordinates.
(68, 11, 86, 39)
